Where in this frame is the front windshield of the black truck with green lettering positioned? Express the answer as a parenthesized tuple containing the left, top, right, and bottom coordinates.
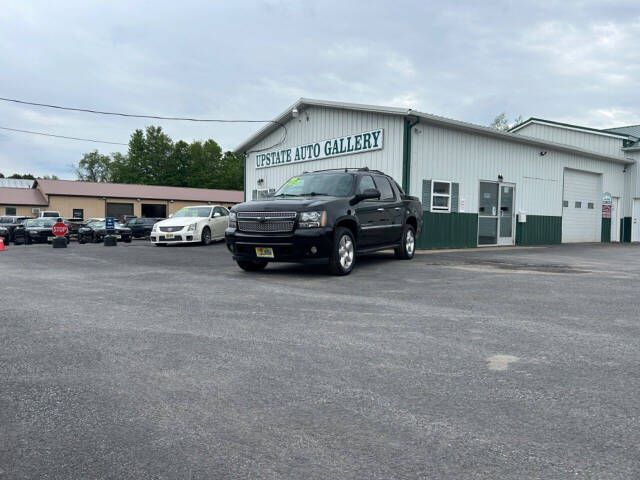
(274, 173, 354, 197)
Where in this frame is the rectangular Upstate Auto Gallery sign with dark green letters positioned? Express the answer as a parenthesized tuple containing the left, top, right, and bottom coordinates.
(256, 128, 383, 168)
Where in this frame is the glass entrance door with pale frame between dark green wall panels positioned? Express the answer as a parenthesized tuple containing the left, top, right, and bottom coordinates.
(478, 182, 515, 245)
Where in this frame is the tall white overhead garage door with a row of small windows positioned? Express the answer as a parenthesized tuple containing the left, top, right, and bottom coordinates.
(562, 169, 602, 243)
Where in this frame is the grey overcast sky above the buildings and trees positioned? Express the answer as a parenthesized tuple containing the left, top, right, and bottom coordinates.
(0, 0, 640, 178)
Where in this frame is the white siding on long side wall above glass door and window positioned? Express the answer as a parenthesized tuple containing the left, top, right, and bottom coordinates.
(409, 124, 625, 217)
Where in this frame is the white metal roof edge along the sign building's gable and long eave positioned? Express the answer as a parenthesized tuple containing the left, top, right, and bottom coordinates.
(234, 98, 635, 165)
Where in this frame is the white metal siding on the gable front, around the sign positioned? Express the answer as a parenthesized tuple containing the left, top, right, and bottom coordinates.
(245, 107, 404, 195)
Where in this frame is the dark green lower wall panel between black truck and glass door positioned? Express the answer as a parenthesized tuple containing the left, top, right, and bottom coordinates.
(416, 212, 478, 249)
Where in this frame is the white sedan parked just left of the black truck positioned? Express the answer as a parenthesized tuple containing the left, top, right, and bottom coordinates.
(151, 205, 229, 246)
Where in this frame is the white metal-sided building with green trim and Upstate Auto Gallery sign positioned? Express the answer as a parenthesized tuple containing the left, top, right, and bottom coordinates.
(236, 98, 640, 248)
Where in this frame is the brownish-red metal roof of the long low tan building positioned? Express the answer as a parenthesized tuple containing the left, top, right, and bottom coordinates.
(37, 179, 244, 203)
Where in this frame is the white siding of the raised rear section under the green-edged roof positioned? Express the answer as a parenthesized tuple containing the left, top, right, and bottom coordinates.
(515, 123, 624, 158)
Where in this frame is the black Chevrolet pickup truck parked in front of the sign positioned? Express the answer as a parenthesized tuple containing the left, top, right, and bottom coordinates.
(226, 168, 422, 275)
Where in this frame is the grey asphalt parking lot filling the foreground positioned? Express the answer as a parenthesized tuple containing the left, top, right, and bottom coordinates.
(0, 241, 640, 479)
